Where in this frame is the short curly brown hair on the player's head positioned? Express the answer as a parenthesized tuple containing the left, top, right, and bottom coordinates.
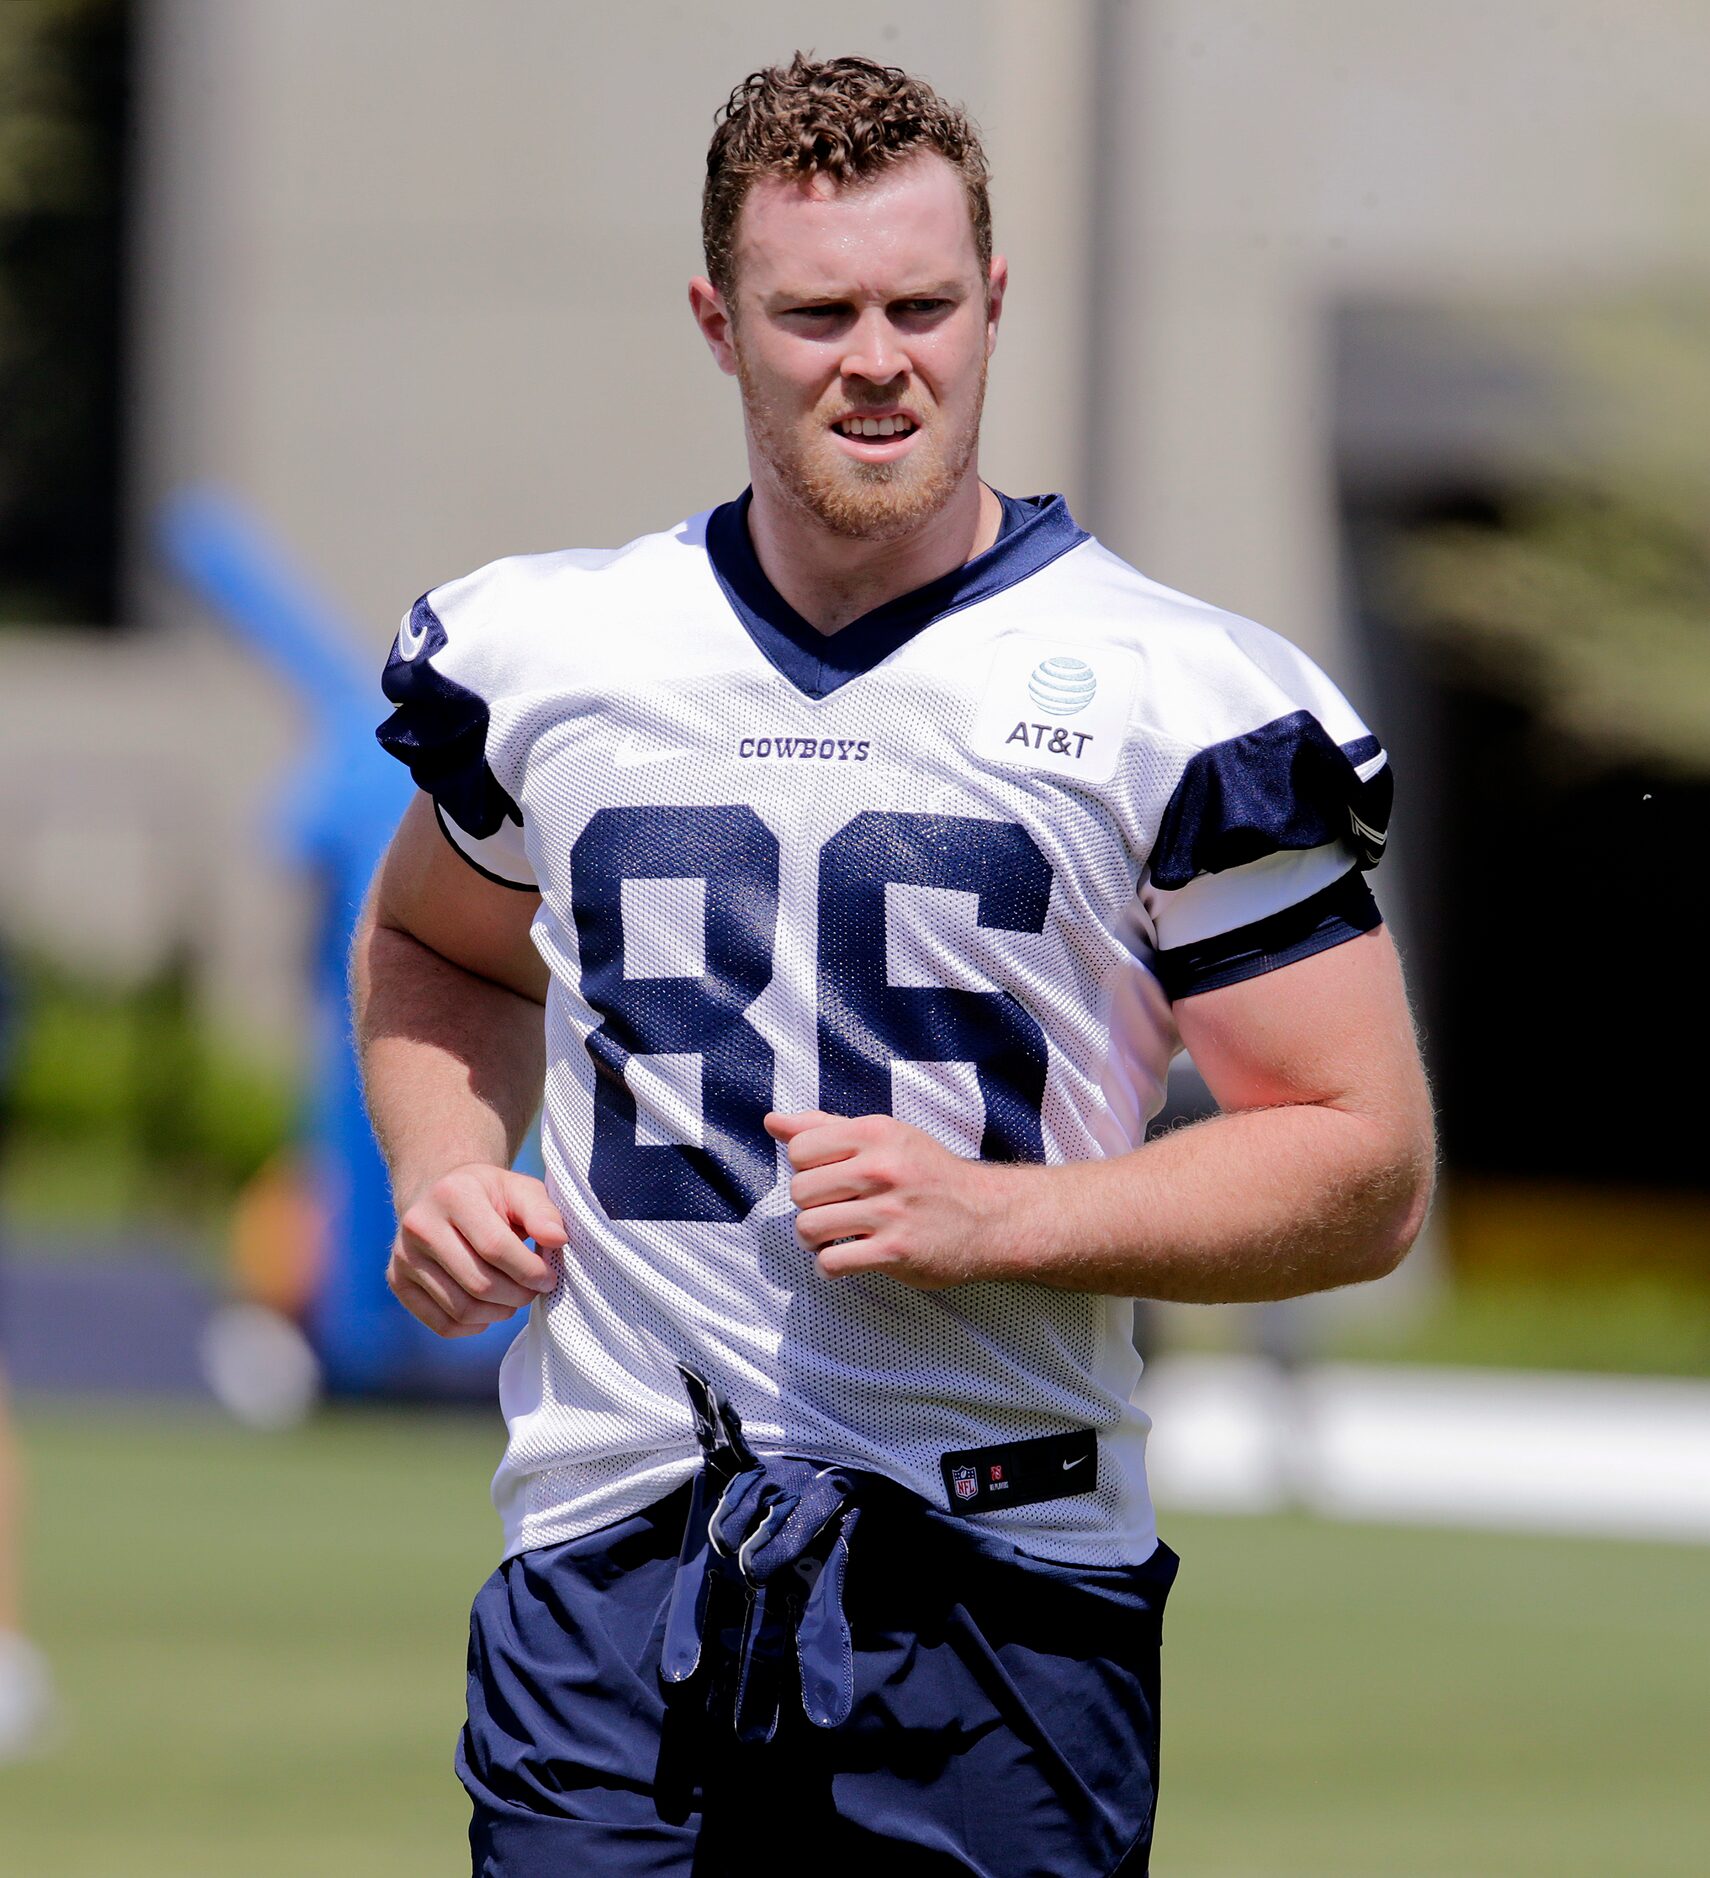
(700, 53, 991, 299)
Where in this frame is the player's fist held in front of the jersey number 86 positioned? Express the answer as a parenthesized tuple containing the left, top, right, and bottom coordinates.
(766, 1108, 1019, 1290)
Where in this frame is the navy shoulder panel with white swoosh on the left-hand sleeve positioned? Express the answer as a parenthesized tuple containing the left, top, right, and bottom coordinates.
(374, 597, 522, 841)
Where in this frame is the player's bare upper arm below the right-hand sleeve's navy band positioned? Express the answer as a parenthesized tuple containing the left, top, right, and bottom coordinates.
(1175, 926, 1432, 1153)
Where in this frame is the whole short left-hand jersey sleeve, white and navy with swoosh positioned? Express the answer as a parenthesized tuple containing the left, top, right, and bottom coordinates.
(375, 590, 537, 892)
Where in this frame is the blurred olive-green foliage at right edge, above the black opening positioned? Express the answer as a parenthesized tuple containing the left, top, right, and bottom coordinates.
(1387, 295, 1710, 776)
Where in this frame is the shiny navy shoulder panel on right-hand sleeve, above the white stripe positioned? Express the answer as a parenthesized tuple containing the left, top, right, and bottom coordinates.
(1149, 710, 1395, 888)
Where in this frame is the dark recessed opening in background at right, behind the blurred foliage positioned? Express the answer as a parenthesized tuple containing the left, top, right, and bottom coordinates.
(1336, 308, 1710, 1209)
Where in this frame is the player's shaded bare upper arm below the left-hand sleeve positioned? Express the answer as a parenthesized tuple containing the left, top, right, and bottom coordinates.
(372, 793, 548, 1003)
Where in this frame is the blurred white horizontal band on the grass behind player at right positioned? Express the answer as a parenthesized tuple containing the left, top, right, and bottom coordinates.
(1134, 1356, 1710, 1544)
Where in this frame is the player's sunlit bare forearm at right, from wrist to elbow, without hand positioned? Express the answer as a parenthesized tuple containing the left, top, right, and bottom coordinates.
(987, 1104, 1432, 1303)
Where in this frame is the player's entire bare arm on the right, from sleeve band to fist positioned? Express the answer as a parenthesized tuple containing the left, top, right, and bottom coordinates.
(780, 930, 1434, 1303)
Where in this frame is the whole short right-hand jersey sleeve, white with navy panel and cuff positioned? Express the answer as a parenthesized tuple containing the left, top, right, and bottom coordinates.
(1141, 620, 1393, 999)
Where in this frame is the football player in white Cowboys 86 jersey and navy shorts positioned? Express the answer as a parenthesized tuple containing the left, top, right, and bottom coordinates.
(355, 56, 1432, 1878)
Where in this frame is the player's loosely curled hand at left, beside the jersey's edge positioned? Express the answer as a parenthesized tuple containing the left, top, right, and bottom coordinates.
(387, 1161, 569, 1337)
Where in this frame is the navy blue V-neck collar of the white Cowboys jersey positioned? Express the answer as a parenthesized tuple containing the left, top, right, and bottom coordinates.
(706, 488, 1089, 699)
